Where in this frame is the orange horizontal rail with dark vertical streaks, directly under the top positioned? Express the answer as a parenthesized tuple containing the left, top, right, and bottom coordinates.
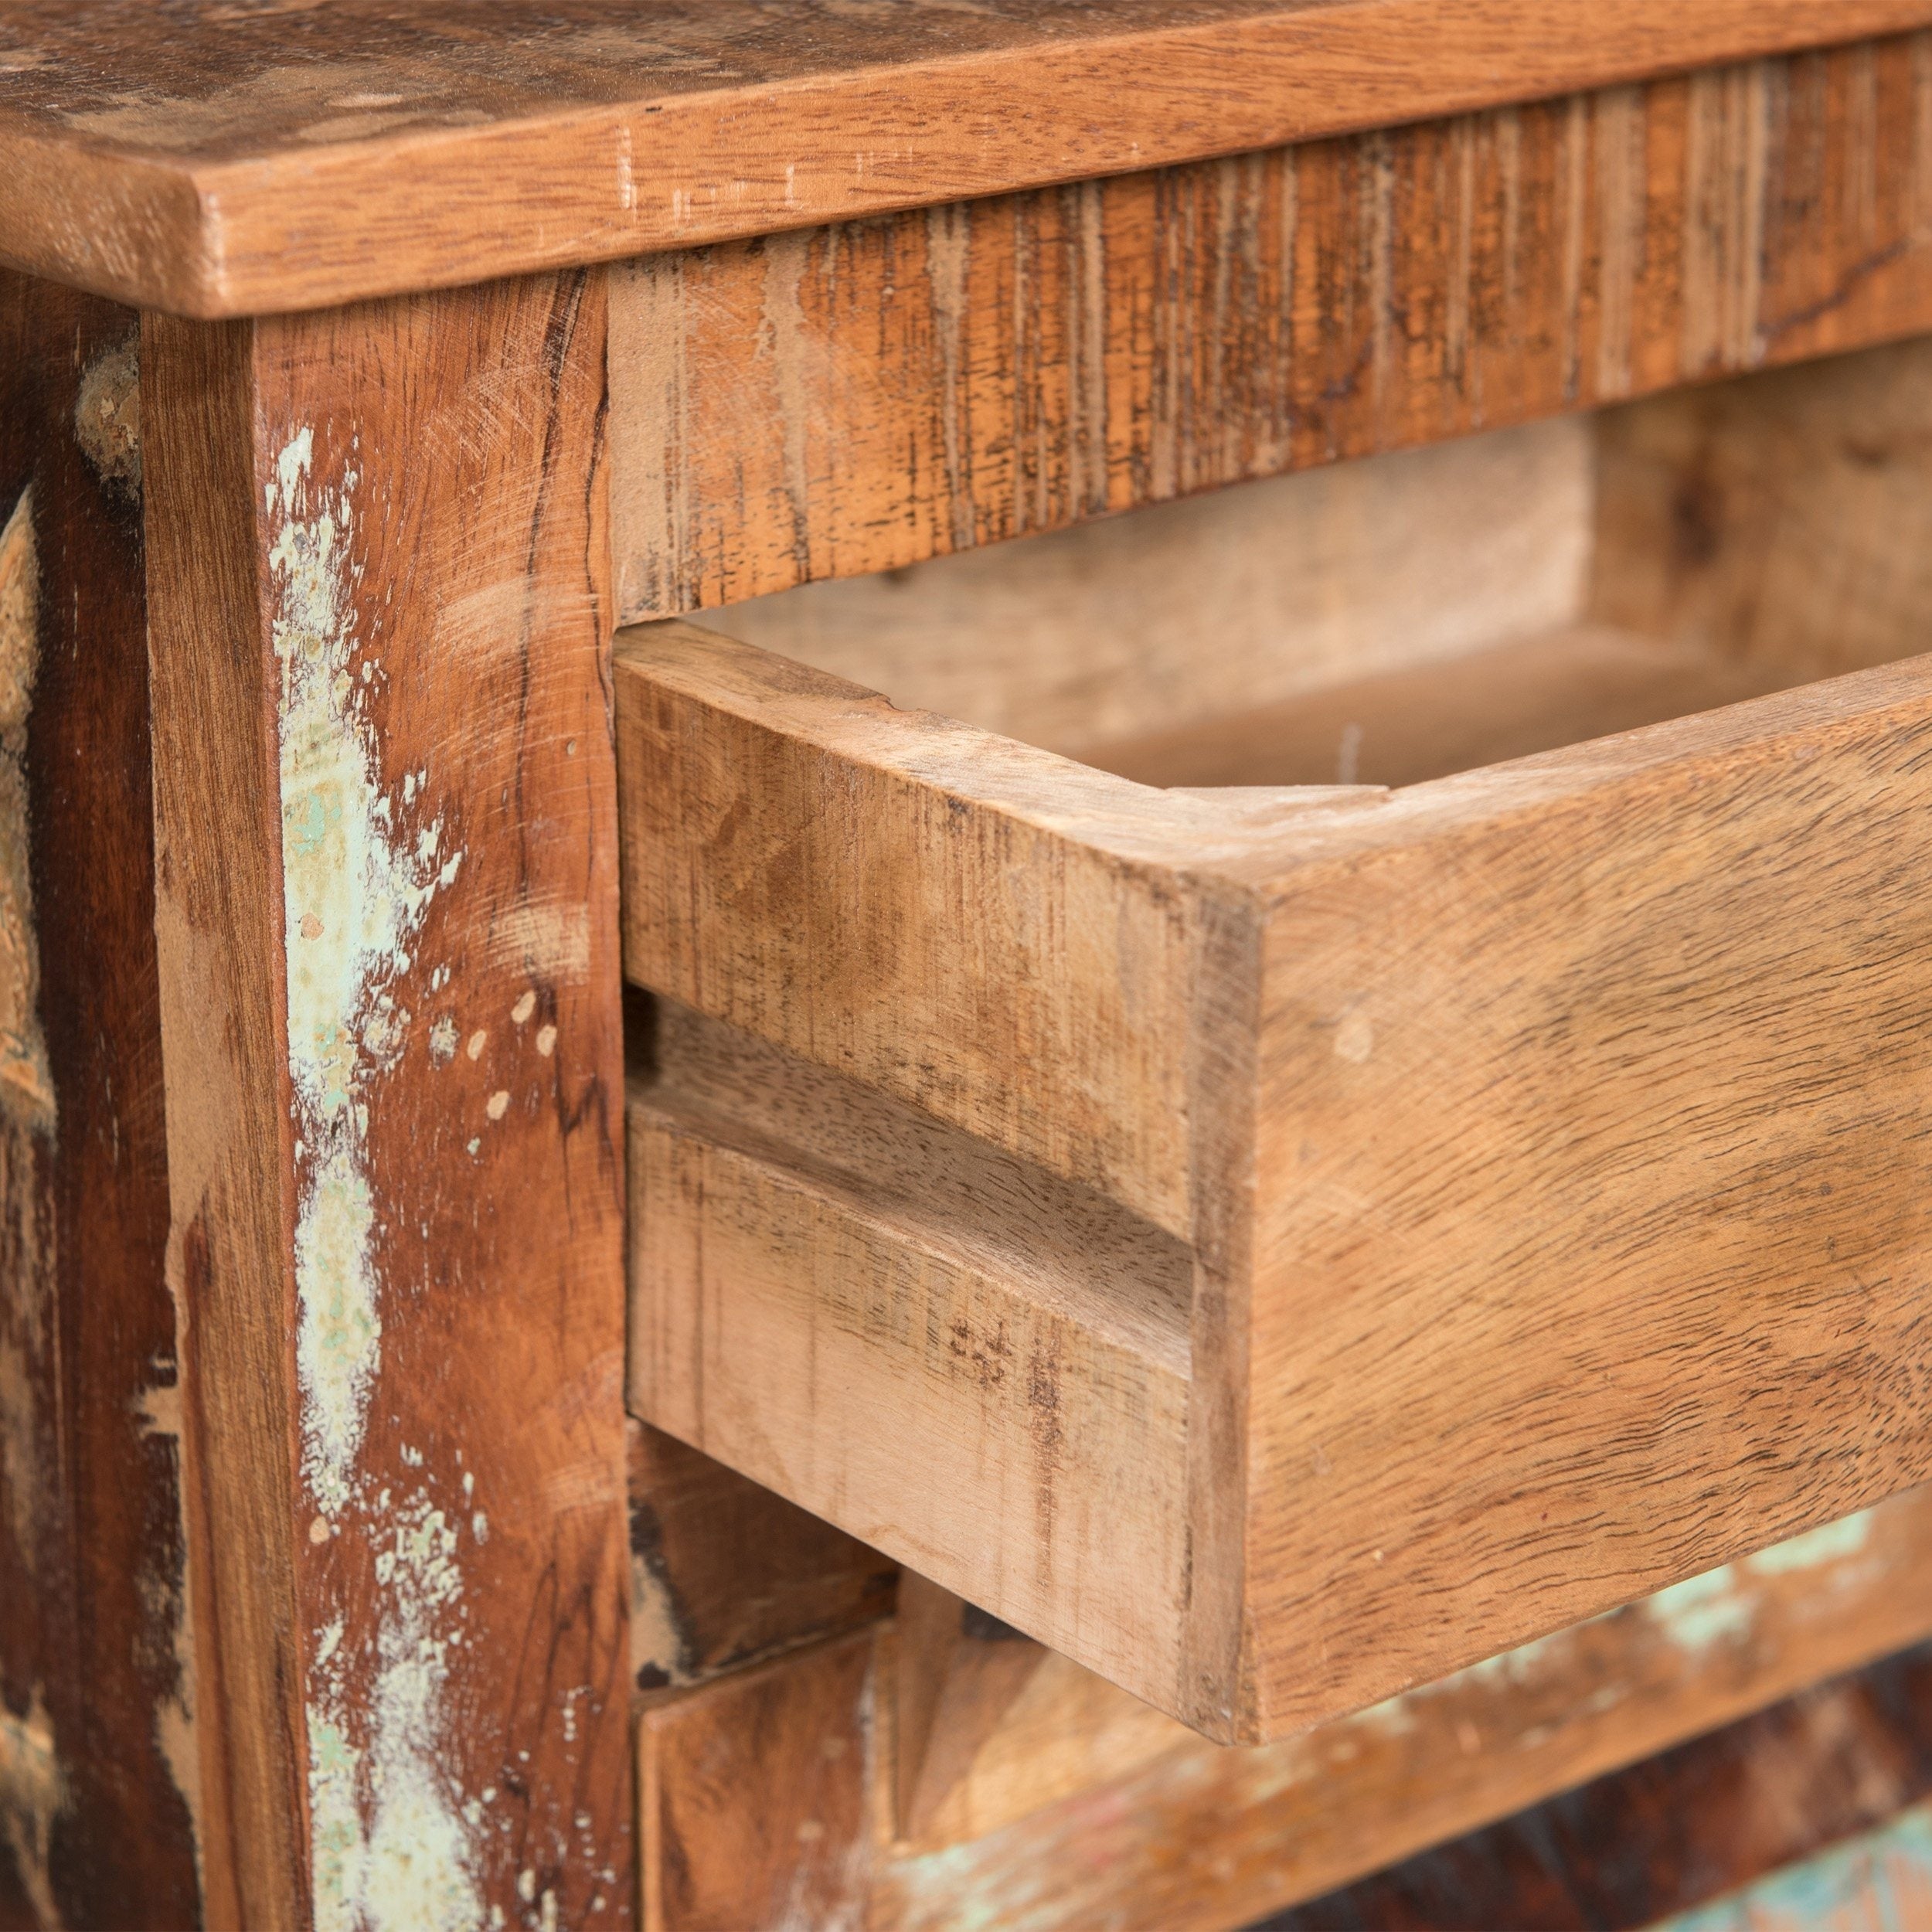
(611, 32, 1932, 621)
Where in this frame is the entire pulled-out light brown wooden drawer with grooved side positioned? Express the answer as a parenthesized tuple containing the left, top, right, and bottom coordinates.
(617, 346, 1932, 1739)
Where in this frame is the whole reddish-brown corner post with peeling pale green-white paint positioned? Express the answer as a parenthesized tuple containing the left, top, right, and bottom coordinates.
(143, 277, 632, 1928)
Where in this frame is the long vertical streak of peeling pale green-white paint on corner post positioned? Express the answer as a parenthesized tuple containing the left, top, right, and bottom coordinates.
(267, 429, 483, 1932)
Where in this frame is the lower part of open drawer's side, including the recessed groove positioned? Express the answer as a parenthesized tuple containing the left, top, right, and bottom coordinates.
(630, 1001, 1189, 1696)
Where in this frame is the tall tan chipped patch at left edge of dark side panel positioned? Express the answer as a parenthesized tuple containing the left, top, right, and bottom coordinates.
(0, 491, 54, 1134)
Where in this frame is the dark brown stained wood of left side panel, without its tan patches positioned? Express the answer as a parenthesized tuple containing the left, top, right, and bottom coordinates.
(0, 274, 201, 1927)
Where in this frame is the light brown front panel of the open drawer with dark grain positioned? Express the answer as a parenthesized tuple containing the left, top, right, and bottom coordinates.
(1247, 663, 1932, 1730)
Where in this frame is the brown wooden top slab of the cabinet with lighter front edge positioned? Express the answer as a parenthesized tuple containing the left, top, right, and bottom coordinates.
(0, 0, 1932, 317)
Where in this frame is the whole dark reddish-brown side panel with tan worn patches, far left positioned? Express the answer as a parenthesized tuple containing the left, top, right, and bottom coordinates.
(0, 274, 199, 1928)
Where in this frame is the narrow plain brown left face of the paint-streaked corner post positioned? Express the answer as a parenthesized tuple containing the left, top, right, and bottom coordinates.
(141, 298, 308, 1928)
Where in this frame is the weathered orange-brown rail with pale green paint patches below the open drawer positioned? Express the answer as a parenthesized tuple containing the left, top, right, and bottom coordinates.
(869, 1492, 1932, 1932)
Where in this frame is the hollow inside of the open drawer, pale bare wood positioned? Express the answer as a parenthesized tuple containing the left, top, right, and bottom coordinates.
(706, 342, 1932, 788)
